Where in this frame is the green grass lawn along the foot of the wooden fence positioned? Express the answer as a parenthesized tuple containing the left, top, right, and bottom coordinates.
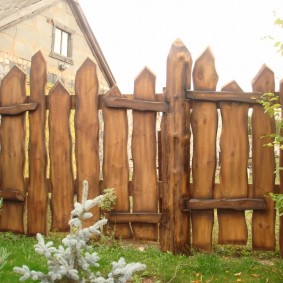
(0, 233, 283, 283)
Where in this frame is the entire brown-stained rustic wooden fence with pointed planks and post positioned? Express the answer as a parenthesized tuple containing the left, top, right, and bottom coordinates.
(0, 41, 283, 254)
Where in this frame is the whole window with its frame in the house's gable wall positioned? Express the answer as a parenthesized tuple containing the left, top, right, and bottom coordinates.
(50, 23, 73, 64)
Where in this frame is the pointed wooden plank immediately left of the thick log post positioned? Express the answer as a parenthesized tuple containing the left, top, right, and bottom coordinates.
(132, 68, 159, 240)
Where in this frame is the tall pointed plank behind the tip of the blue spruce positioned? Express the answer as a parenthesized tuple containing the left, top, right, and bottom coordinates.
(75, 58, 100, 225)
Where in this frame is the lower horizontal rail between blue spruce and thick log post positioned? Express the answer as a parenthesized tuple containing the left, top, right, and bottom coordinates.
(108, 212, 162, 224)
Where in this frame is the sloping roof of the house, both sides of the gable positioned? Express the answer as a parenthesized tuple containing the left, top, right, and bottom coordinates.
(0, 0, 116, 86)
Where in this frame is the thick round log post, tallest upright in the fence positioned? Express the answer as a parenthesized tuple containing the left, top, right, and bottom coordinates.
(160, 39, 192, 254)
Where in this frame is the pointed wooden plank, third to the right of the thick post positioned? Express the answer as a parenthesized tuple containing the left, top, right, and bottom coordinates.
(252, 65, 275, 250)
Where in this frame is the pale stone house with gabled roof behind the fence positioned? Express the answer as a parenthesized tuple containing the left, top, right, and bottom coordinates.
(0, 0, 115, 93)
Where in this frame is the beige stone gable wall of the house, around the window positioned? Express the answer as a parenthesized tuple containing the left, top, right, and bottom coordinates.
(0, 1, 109, 93)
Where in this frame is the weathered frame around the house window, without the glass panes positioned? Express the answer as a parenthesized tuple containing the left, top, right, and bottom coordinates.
(49, 21, 74, 65)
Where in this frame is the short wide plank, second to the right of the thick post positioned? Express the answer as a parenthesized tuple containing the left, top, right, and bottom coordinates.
(218, 81, 249, 244)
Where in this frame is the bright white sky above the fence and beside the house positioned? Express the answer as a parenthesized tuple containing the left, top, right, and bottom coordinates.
(79, 0, 283, 93)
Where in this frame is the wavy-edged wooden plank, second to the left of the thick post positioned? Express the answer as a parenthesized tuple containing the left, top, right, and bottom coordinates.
(103, 86, 132, 238)
